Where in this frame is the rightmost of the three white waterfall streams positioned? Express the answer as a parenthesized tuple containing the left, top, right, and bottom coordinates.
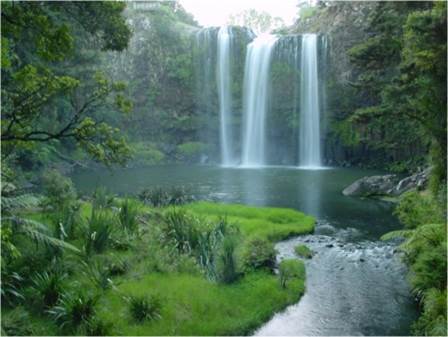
(299, 34, 322, 168)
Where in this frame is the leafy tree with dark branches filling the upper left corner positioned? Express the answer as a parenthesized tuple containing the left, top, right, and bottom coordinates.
(1, 2, 132, 163)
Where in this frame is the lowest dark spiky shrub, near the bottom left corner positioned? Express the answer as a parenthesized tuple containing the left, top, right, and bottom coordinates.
(47, 292, 98, 332)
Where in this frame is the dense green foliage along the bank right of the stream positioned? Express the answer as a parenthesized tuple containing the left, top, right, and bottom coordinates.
(382, 187, 447, 336)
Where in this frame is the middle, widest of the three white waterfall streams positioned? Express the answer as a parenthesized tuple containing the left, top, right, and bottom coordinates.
(241, 35, 277, 167)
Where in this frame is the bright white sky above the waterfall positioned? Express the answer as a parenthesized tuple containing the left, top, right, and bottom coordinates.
(180, 0, 298, 27)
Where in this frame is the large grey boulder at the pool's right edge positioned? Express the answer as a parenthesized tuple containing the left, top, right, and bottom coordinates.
(342, 174, 399, 197)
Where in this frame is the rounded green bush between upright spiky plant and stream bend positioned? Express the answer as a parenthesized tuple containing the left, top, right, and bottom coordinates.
(242, 237, 276, 270)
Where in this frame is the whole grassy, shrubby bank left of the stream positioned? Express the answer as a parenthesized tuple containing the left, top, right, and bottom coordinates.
(2, 172, 314, 335)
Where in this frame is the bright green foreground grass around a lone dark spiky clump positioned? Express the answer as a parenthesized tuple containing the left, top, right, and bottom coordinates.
(99, 272, 304, 336)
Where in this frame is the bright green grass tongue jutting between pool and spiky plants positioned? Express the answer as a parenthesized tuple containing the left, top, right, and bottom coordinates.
(183, 201, 315, 241)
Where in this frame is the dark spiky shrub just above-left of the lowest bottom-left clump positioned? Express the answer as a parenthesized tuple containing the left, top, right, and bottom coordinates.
(32, 271, 66, 308)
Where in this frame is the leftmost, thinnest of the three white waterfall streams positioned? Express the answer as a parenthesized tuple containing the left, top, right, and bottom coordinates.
(217, 26, 235, 166)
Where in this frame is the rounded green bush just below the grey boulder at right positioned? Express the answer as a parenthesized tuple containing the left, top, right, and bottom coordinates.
(394, 191, 445, 228)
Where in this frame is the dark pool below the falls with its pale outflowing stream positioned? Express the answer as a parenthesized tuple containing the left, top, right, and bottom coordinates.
(72, 165, 416, 335)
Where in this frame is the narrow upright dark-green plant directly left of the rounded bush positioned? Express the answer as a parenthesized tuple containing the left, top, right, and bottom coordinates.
(216, 235, 238, 283)
